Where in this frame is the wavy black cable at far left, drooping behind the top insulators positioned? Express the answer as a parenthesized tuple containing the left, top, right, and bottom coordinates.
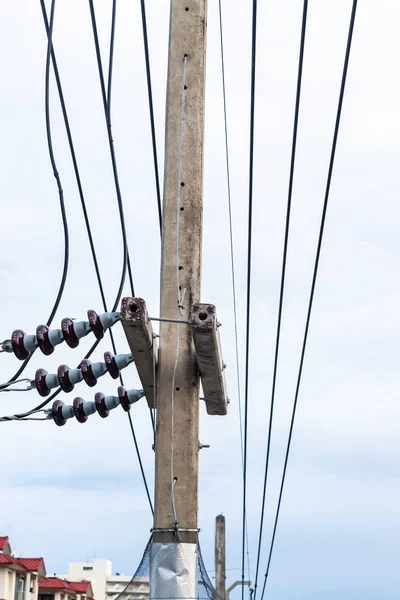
(0, 0, 69, 389)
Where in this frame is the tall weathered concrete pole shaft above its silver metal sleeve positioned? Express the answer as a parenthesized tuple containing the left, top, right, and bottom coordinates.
(154, 0, 207, 544)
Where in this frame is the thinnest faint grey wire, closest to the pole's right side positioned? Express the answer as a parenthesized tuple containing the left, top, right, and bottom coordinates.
(218, 0, 250, 592)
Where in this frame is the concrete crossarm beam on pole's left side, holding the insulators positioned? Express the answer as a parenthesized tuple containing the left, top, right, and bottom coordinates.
(121, 297, 158, 408)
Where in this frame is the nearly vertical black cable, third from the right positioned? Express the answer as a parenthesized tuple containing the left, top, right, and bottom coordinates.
(242, 0, 257, 600)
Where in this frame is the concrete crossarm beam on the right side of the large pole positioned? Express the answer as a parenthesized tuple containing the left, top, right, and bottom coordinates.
(189, 304, 228, 415)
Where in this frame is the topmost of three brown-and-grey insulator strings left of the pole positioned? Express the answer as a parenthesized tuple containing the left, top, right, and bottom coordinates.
(2, 310, 120, 360)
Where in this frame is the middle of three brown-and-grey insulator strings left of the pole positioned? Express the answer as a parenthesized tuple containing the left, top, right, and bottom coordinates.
(35, 352, 133, 397)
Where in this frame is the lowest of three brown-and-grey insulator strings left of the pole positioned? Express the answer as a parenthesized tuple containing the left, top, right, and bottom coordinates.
(51, 386, 144, 427)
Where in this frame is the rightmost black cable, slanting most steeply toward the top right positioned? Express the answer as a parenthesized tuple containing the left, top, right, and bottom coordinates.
(261, 0, 357, 600)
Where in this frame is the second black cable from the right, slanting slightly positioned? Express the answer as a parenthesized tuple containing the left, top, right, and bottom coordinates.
(254, 0, 308, 600)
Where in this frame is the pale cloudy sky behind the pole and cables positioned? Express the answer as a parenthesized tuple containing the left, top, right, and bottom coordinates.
(0, 0, 400, 600)
